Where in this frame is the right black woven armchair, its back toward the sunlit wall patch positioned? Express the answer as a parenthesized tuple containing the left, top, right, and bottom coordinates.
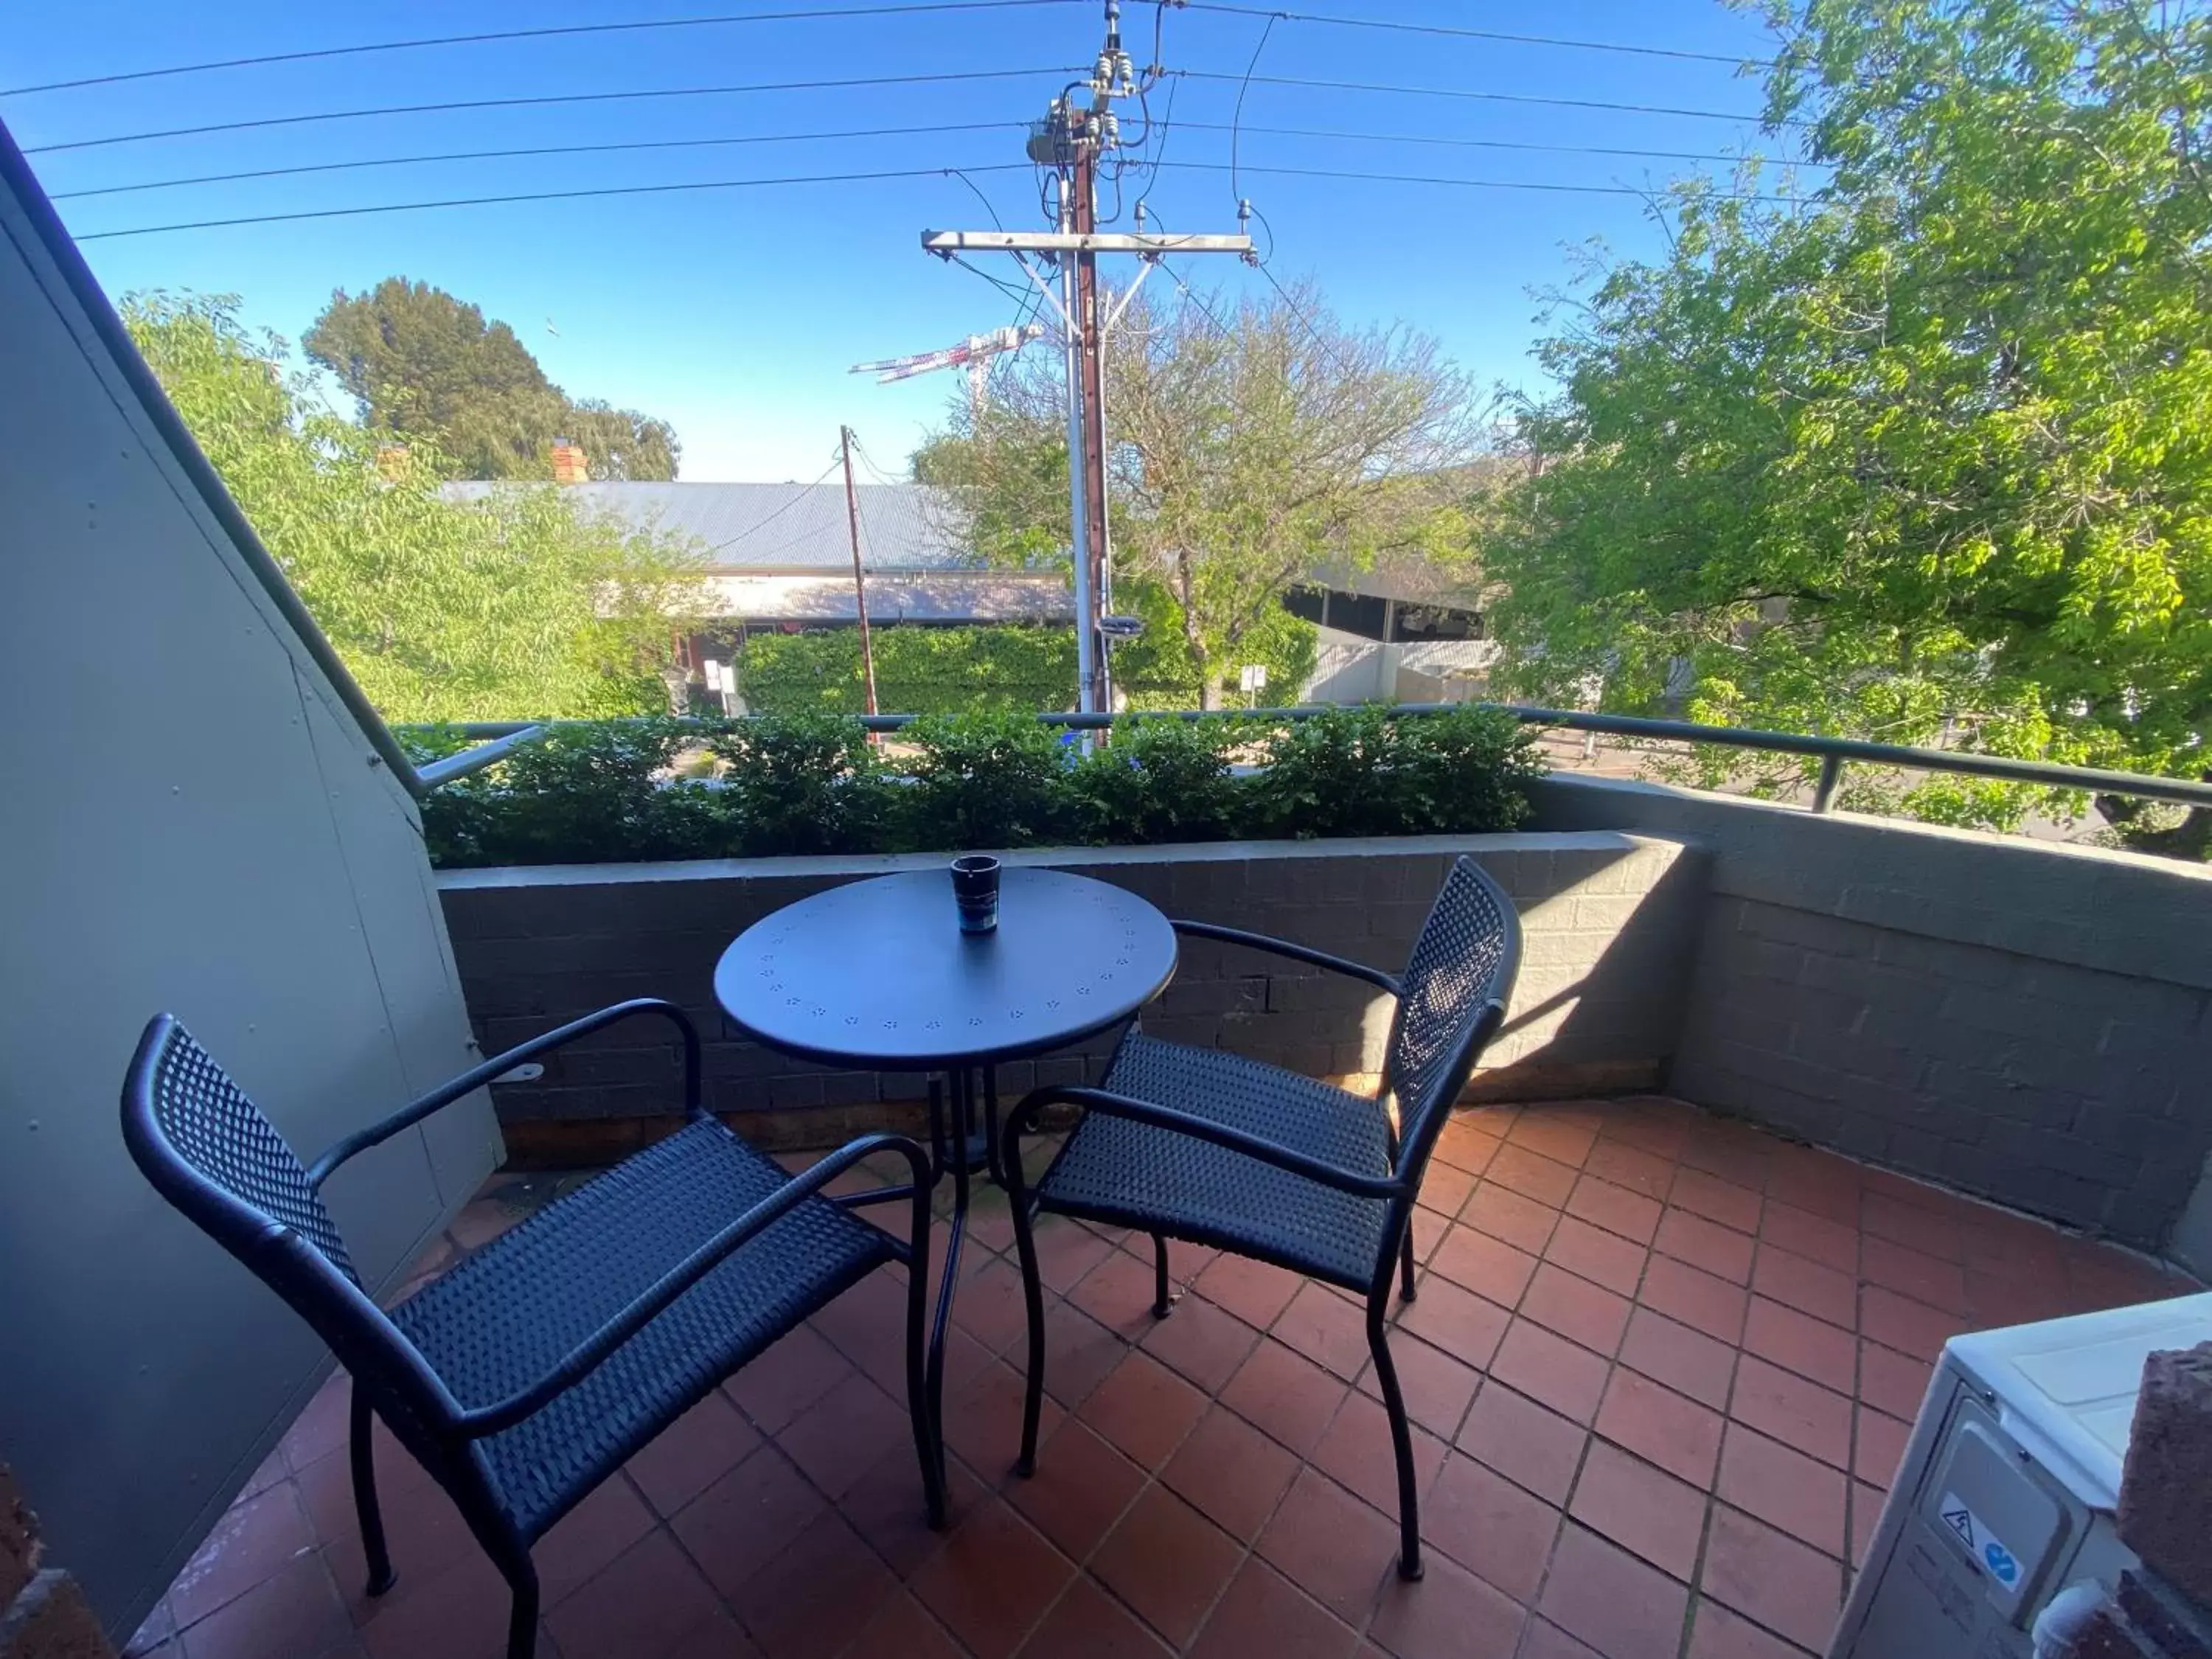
(1000, 858, 1520, 1579)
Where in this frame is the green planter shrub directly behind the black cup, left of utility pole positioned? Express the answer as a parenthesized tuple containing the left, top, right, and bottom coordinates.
(900, 714, 1077, 847)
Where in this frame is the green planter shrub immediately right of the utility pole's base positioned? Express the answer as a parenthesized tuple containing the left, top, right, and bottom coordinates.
(1068, 714, 1254, 845)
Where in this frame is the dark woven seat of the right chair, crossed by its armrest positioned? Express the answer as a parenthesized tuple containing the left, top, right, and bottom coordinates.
(1037, 1031, 1391, 1290)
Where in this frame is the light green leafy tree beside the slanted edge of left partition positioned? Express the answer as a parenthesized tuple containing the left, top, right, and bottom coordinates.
(124, 294, 692, 721)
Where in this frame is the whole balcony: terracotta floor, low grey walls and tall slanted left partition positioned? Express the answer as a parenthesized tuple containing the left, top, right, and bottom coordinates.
(0, 111, 2212, 1659)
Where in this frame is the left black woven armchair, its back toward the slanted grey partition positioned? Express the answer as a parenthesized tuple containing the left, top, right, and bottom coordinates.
(124, 998, 945, 1659)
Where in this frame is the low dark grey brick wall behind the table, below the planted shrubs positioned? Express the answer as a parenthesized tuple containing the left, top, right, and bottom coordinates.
(438, 834, 1703, 1146)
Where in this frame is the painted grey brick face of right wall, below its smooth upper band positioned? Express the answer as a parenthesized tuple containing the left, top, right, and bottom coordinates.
(1674, 896, 2212, 1245)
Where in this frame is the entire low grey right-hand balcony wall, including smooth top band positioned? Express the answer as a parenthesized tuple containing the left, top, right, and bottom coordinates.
(1537, 776, 2212, 1265)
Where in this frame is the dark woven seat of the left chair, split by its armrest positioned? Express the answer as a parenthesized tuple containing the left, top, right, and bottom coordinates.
(392, 1121, 896, 1537)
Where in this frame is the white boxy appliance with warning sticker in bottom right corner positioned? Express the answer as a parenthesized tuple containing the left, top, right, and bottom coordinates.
(1827, 1294, 2212, 1659)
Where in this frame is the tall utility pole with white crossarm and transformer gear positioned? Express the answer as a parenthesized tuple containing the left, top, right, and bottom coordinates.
(922, 0, 1252, 714)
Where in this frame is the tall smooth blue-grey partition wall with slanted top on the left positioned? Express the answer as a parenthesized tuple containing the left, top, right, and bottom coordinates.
(0, 139, 498, 1637)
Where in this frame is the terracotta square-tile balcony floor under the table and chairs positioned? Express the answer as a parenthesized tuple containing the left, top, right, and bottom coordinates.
(133, 1097, 2194, 1659)
